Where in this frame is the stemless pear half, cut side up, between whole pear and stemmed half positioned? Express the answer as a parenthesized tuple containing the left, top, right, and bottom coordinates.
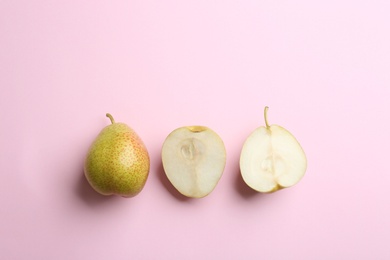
(161, 126, 226, 198)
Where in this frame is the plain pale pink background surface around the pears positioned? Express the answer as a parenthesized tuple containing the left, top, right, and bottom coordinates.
(0, 0, 390, 259)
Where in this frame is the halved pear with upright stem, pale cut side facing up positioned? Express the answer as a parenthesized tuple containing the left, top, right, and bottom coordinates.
(240, 107, 307, 193)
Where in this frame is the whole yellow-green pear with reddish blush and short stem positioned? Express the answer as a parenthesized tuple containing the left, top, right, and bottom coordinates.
(84, 114, 150, 197)
